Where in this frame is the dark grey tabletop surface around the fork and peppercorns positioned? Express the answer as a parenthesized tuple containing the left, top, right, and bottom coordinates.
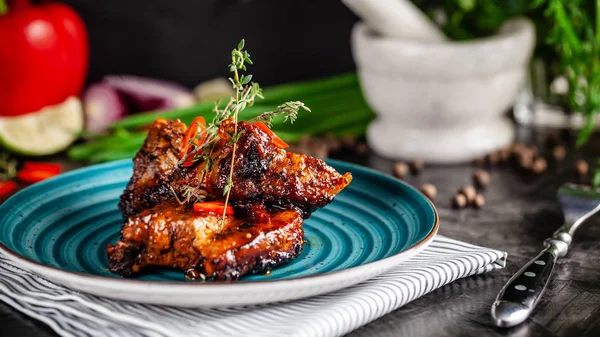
(0, 124, 600, 337)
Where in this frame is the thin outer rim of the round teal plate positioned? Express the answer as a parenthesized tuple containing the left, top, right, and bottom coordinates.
(0, 159, 439, 293)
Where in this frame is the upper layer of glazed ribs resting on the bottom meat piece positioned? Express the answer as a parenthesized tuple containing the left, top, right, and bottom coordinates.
(120, 120, 352, 221)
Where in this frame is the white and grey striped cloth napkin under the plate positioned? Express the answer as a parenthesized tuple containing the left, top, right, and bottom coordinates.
(0, 235, 506, 337)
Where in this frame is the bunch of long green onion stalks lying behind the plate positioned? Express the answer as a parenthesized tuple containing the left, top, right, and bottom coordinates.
(68, 73, 374, 163)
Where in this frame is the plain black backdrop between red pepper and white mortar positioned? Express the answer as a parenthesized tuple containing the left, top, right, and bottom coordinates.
(61, 0, 357, 87)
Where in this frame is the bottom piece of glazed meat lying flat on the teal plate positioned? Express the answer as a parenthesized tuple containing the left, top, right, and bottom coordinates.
(107, 202, 304, 281)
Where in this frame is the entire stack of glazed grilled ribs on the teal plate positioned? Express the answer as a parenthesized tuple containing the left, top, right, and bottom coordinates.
(107, 119, 352, 280)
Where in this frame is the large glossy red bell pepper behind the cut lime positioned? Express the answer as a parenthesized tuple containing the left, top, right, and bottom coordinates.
(0, 0, 88, 116)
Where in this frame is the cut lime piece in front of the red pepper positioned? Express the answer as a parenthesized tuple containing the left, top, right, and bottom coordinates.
(0, 97, 84, 156)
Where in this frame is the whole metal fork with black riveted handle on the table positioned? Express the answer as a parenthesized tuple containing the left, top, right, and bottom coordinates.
(492, 184, 600, 327)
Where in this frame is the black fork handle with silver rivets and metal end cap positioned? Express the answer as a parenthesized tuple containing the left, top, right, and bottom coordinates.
(492, 244, 558, 327)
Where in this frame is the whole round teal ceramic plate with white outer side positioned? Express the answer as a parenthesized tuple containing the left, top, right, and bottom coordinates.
(0, 160, 438, 307)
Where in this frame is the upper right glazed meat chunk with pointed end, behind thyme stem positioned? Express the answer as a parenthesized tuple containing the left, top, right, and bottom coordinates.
(171, 120, 352, 220)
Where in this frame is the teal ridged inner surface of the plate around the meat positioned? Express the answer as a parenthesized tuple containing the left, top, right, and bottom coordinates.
(0, 160, 437, 281)
